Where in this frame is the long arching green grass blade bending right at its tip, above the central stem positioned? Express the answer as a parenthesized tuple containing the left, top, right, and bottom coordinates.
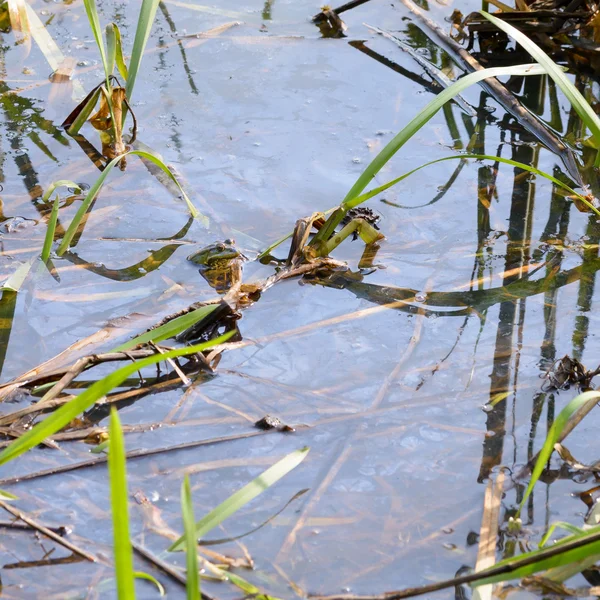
(344, 64, 545, 202)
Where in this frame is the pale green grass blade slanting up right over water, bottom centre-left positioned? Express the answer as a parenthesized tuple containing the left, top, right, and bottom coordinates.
(169, 447, 310, 552)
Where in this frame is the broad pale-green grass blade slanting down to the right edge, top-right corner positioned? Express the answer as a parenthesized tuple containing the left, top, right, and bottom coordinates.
(479, 10, 600, 154)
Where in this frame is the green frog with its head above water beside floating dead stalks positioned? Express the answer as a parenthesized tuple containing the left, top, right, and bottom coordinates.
(187, 240, 246, 294)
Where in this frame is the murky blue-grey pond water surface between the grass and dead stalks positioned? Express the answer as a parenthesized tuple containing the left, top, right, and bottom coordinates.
(0, 0, 600, 598)
